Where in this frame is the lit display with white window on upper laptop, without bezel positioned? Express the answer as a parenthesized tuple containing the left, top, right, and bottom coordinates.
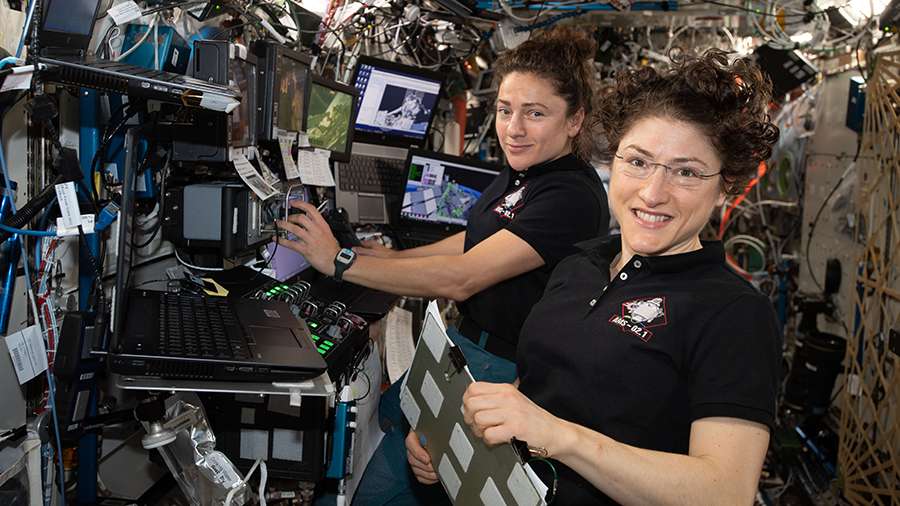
(354, 64, 441, 139)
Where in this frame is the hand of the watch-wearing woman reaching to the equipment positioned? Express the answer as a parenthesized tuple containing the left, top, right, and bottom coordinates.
(275, 200, 341, 276)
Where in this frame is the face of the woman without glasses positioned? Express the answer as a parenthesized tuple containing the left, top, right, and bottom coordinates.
(497, 72, 584, 170)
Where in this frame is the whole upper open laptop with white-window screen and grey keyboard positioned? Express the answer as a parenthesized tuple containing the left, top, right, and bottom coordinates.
(334, 56, 444, 223)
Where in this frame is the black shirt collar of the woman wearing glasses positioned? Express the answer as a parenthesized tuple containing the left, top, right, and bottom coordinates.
(576, 234, 725, 274)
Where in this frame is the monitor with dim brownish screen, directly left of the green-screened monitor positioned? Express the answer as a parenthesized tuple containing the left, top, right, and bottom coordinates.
(254, 41, 311, 141)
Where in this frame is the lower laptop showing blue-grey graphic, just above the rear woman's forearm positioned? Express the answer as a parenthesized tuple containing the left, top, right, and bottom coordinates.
(393, 148, 502, 249)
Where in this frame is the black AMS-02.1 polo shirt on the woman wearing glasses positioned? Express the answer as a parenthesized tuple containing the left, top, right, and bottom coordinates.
(516, 235, 781, 504)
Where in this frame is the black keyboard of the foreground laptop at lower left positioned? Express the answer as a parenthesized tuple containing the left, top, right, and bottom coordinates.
(158, 292, 249, 359)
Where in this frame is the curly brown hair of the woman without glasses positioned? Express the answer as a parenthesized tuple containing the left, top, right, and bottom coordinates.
(491, 26, 600, 162)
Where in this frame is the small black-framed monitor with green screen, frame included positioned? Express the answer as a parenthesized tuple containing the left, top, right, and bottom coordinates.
(306, 73, 359, 162)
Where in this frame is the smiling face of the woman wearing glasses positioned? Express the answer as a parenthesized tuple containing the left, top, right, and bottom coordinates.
(609, 117, 725, 265)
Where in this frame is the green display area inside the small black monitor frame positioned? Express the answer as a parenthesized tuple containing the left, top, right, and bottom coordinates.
(306, 82, 353, 153)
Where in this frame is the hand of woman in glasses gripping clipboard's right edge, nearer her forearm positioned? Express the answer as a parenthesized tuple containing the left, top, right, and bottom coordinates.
(463, 381, 565, 457)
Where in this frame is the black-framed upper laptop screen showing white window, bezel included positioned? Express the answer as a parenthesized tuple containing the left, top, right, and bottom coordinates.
(351, 56, 444, 147)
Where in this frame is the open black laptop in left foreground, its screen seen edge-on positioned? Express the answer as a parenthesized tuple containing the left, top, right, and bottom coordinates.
(107, 128, 327, 383)
